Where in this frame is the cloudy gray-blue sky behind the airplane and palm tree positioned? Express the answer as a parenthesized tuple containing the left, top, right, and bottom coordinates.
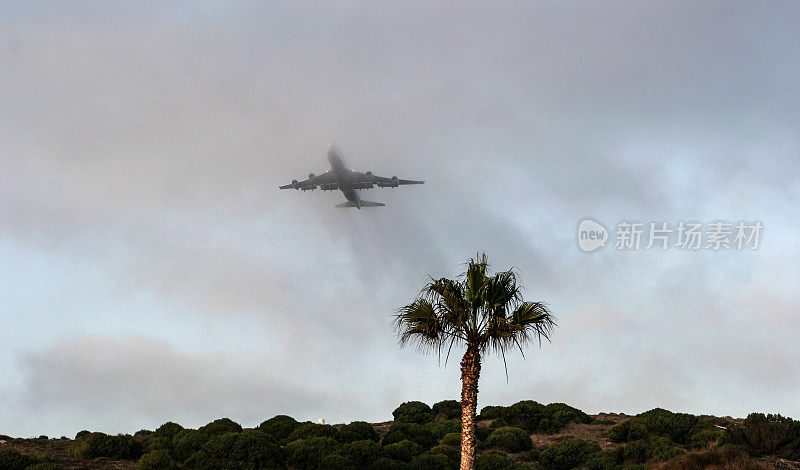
(0, 1, 800, 436)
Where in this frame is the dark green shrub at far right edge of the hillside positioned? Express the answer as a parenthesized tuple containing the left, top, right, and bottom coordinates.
(723, 413, 800, 455)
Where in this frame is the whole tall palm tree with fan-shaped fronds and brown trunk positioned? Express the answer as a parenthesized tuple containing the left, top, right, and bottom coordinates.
(394, 254, 556, 470)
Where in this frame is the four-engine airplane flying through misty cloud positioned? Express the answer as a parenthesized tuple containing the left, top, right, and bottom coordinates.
(279, 144, 425, 210)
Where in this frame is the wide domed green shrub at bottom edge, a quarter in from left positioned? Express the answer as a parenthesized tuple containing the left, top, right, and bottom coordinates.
(183, 429, 285, 470)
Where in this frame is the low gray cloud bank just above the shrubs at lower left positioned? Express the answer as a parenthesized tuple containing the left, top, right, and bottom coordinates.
(14, 336, 346, 433)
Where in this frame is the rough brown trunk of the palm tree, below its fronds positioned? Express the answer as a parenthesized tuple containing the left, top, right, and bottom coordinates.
(461, 344, 481, 470)
